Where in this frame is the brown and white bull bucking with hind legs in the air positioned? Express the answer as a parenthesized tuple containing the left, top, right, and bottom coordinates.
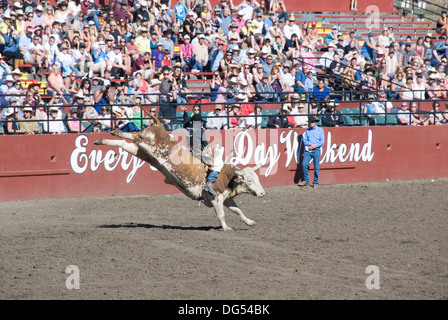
(95, 112, 265, 231)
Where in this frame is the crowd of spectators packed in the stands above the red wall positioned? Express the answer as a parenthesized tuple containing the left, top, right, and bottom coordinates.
(0, 0, 448, 134)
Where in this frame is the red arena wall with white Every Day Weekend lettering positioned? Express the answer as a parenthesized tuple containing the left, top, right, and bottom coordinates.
(0, 126, 448, 201)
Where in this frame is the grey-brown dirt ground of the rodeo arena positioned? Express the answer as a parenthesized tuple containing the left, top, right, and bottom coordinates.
(0, 179, 448, 300)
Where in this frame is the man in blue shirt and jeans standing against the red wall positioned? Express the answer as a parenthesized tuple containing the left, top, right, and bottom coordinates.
(299, 116, 325, 187)
